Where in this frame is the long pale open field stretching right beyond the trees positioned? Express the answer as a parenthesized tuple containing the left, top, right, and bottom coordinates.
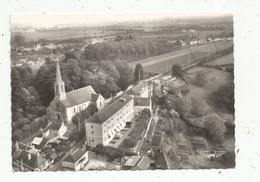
(129, 41, 233, 73)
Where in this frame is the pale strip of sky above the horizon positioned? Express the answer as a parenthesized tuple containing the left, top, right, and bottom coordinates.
(10, 13, 231, 27)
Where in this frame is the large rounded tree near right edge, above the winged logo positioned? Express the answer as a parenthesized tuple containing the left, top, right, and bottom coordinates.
(204, 114, 226, 142)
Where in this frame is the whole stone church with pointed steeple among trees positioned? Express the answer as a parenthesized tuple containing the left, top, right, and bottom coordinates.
(47, 62, 105, 124)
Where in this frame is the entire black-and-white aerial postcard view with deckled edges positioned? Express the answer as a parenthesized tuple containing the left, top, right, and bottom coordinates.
(10, 13, 236, 172)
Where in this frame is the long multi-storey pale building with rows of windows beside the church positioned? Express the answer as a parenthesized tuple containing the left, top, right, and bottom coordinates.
(85, 95, 134, 146)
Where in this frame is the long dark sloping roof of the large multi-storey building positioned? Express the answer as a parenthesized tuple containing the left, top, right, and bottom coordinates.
(87, 95, 133, 123)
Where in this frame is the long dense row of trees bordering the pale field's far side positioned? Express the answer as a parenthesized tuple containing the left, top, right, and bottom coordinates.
(84, 38, 178, 61)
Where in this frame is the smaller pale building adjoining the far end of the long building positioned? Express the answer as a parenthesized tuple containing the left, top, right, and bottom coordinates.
(134, 97, 152, 116)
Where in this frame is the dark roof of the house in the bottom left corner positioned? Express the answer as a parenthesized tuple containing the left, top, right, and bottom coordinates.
(18, 150, 48, 169)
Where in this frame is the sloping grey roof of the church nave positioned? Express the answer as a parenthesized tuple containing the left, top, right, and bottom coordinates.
(61, 85, 96, 108)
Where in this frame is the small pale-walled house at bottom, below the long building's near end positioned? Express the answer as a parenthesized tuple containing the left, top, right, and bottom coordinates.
(61, 149, 88, 171)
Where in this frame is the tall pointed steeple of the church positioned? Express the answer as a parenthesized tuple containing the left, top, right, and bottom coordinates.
(54, 61, 66, 100)
